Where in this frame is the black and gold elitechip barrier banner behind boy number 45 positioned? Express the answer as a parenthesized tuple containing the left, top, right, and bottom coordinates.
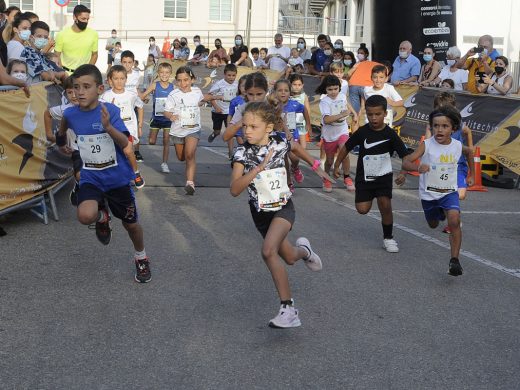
(394, 86, 520, 155)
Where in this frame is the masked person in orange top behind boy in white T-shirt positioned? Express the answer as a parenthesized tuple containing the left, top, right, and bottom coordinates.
(347, 43, 381, 112)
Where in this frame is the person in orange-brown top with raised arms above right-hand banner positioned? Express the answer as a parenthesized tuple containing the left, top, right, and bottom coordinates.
(457, 35, 500, 93)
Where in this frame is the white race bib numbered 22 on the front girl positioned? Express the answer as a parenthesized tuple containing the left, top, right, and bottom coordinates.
(253, 168, 292, 211)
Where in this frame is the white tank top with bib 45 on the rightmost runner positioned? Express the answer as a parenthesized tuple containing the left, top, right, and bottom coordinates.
(419, 137, 462, 200)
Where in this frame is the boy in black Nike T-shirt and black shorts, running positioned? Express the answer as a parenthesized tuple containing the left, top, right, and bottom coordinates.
(334, 95, 408, 253)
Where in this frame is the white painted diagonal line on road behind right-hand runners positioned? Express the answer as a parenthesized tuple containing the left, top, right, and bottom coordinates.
(302, 188, 520, 279)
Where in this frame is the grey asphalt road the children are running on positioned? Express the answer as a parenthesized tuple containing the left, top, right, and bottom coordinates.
(0, 107, 520, 390)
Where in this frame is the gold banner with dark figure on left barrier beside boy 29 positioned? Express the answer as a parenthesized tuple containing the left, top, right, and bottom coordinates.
(0, 83, 72, 210)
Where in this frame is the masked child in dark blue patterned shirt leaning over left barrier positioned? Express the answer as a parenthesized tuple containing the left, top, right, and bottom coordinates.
(20, 21, 67, 83)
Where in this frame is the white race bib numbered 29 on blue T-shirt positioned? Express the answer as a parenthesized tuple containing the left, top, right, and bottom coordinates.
(76, 133, 117, 171)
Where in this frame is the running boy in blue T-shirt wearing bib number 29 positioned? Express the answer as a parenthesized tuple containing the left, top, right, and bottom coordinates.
(56, 64, 152, 283)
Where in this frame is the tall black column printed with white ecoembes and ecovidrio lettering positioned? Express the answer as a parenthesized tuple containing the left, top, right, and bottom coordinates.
(372, 0, 457, 62)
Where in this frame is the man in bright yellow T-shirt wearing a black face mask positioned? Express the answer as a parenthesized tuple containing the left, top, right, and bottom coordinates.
(54, 4, 98, 73)
